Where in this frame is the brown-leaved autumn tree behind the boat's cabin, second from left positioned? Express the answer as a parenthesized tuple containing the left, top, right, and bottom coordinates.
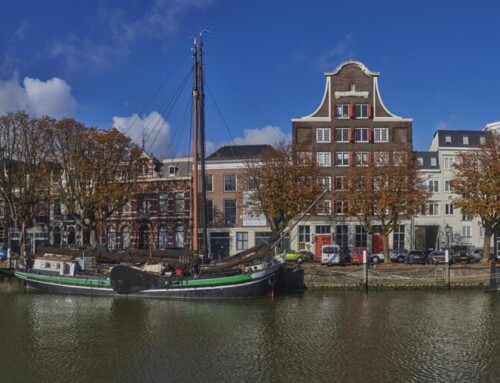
(50, 119, 142, 246)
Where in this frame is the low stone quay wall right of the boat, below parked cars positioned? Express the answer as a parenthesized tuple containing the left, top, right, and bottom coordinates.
(283, 264, 491, 289)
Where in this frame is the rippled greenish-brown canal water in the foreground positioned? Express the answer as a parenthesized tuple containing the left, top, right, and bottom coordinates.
(0, 276, 500, 383)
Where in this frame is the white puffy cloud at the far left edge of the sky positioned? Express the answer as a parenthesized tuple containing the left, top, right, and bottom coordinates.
(0, 76, 77, 118)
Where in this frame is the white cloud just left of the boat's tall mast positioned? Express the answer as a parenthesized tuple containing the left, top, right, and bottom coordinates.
(113, 111, 171, 158)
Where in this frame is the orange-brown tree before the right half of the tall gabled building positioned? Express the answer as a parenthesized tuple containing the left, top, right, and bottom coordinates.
(344, 148, 429, 260)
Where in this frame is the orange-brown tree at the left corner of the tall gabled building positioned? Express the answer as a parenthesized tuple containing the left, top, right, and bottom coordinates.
(242, 142, 322, 240)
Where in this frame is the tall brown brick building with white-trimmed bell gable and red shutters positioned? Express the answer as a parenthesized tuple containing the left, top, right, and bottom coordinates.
(292, 61, 413, 253)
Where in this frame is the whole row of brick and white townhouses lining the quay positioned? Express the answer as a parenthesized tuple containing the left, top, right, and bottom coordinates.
(0, 61, 500, 259)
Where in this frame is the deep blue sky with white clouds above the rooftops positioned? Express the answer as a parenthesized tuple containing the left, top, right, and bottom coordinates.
(0, 0, 500, 158)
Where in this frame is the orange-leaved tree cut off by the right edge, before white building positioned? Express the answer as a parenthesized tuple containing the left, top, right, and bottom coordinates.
(450, 134, 500, 262)
